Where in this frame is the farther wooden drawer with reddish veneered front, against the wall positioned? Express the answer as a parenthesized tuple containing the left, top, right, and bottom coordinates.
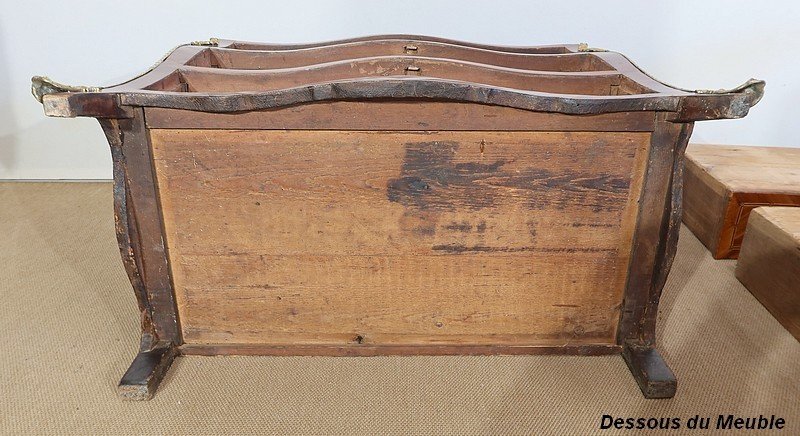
(683, 144, 800, 259)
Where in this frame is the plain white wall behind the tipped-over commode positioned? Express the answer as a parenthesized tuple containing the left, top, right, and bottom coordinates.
(0, 0, 800, 179)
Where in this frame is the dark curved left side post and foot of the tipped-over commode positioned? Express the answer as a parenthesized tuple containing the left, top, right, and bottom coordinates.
(99, 109, 181, 400)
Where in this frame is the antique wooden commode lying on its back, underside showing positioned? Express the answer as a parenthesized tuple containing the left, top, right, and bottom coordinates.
(33, 35, 764, 399)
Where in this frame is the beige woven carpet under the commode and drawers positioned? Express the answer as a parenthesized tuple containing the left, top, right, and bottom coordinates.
(0, 183, 800, 435)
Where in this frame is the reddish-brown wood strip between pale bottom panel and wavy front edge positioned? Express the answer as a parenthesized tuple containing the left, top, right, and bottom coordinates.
(145, 100, 654, 132)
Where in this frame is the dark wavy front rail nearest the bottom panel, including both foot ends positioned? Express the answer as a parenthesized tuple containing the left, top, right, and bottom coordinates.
(39, 77, 768, 122)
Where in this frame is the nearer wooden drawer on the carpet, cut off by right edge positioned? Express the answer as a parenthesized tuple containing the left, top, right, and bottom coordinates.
(736, 207, 800, 341)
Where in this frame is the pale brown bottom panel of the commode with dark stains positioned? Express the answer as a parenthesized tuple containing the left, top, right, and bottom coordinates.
(151, 130, 650, 346)
